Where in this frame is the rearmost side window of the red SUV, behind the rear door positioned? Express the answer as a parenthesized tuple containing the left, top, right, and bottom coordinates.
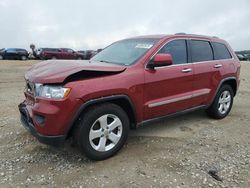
(212, 42, 232, 60)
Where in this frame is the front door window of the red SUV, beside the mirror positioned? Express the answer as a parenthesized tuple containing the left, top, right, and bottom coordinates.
(158, 40, 187, 64)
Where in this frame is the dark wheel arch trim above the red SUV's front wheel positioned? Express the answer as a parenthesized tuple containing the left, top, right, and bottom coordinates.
(64, 95, 136, 137)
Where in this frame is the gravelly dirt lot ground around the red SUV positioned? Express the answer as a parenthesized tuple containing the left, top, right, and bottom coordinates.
(0, 61, 250, 187)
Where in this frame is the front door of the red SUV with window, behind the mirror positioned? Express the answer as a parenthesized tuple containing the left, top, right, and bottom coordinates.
(144, 39, 193, 119)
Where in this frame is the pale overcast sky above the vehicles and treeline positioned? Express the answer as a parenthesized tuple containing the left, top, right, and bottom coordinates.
(0, 0, 250, 50)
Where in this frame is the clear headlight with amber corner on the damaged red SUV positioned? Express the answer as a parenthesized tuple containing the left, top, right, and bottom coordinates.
(35, 84, 70, 99)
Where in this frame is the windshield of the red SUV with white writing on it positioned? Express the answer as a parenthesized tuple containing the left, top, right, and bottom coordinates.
(91, 38, 159, 65)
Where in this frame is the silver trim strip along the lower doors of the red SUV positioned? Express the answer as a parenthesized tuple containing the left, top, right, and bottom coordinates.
(148, 89, 210, 108)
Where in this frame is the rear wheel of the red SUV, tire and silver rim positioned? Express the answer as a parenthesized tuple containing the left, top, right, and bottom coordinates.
(206, 84, 234, 119)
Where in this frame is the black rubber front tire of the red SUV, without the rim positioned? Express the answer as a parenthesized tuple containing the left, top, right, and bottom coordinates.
(77, 104, 129, 160)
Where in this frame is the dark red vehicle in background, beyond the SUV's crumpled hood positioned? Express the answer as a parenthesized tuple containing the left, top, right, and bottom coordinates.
(37, 48, 84, 59)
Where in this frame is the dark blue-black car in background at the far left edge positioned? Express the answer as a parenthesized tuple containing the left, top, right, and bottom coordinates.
(0, 48, 29, 60)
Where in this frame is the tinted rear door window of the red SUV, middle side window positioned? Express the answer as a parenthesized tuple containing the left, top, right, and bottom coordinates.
(190, 40, 213, 62)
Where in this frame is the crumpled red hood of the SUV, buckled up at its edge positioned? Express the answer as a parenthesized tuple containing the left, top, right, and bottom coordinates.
(25, 60, 126, 84)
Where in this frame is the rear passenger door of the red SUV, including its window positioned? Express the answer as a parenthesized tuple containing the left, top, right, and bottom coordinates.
(188, 39, 222, 106)
